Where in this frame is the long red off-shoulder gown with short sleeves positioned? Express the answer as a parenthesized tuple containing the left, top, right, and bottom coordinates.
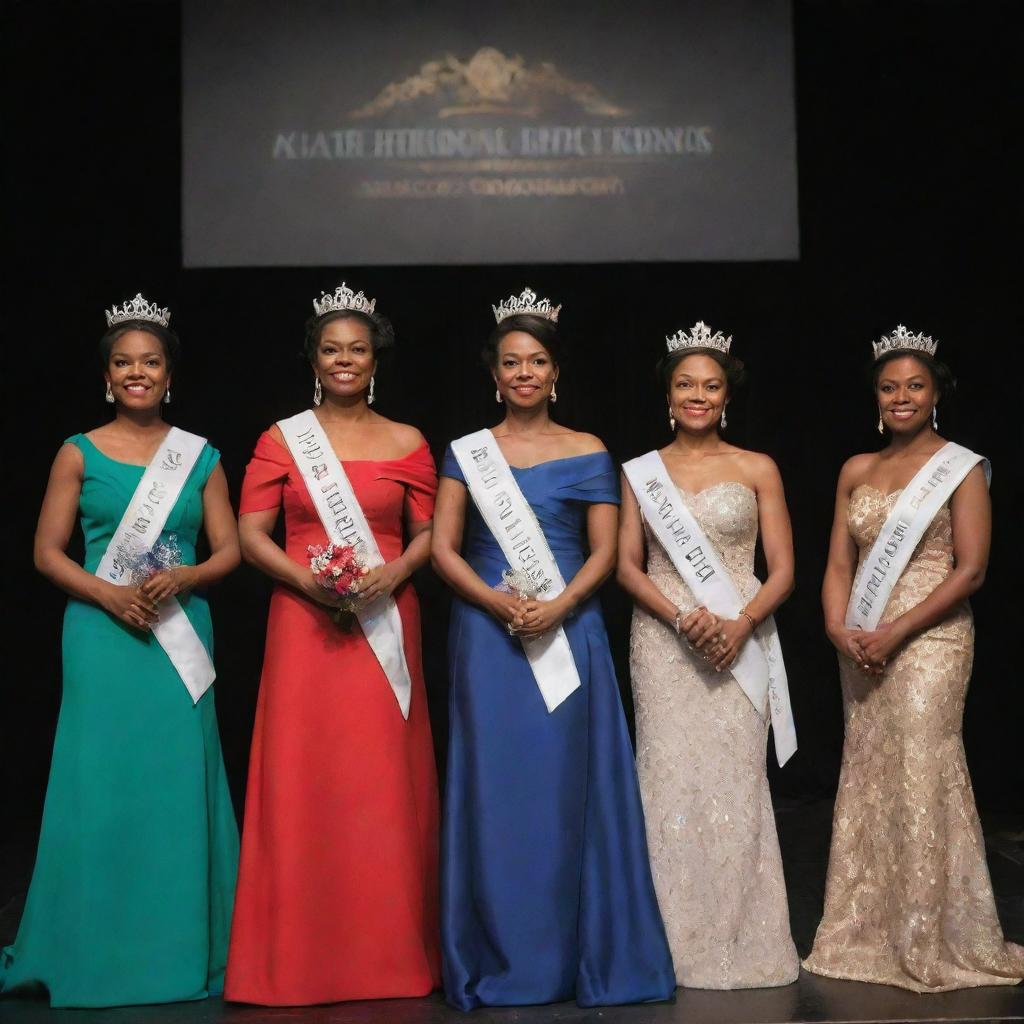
(224, 433, 440, 1006)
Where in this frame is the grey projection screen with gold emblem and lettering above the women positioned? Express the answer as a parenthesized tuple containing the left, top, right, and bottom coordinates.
(182, 0, 798, 266)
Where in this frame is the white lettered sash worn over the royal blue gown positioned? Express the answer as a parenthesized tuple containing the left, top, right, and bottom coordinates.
(452, 430, 581, 712)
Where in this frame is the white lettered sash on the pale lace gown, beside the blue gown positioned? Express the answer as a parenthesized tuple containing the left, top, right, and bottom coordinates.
(623, 452, 797, 766)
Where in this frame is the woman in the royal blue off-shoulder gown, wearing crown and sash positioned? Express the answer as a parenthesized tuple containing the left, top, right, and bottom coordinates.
(431, 289, 675, 1010)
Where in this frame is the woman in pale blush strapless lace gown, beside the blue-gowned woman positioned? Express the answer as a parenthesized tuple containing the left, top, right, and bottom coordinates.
(618, 324, 799, 988)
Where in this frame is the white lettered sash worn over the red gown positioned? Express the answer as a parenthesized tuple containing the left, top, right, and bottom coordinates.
(278, 409, 413, 719)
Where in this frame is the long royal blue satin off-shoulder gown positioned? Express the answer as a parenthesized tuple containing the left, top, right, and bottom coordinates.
(441, 449, 676, 1010)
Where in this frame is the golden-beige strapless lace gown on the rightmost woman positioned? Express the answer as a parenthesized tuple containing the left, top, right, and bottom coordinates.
(804, 485, 1024, 992)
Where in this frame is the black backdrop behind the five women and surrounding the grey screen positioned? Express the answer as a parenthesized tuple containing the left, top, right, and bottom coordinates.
(0, 0, 1024, 827)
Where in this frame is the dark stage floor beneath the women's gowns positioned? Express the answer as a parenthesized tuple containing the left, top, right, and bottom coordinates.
(0, 801, 1024, 1024)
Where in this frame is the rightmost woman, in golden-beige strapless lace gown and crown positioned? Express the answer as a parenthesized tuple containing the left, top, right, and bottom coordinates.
(804, 327, 1024, 992)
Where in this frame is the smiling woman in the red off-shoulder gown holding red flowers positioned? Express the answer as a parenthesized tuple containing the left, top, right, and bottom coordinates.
(225, 285, 440, 1006)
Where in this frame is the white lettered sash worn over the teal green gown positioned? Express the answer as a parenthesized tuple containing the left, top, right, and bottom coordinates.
(96, 427, 217, 703)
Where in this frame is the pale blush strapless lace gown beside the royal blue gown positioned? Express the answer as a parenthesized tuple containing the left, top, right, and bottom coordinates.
(630, 482, 799, 988)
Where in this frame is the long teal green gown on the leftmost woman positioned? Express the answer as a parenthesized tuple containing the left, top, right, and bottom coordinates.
(0, 434, 239, 1007)
